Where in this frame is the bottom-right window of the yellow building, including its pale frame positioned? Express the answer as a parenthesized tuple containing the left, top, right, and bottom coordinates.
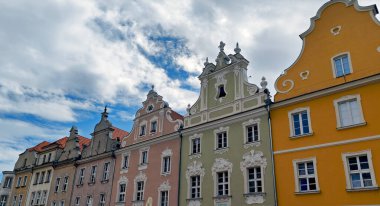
(343, 150, 377, 190)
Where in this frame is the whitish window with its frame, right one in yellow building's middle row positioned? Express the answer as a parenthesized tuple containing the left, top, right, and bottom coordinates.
(334, 95, 364, 128)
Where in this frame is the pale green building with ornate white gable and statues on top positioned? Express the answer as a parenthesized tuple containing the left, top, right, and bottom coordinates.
(179, 42, 275, 206)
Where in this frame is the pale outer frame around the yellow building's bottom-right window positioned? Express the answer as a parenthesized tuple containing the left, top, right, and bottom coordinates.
(342, 150, 378, 191)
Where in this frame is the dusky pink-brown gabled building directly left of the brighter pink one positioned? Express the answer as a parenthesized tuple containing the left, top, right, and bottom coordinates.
(70, 108, 128, 206)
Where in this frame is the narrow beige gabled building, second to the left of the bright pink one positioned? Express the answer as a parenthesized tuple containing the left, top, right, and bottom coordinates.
(46, 126, 90, 206)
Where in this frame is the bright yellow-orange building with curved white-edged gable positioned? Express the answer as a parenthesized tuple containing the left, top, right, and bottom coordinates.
(271, 0, 380, 206)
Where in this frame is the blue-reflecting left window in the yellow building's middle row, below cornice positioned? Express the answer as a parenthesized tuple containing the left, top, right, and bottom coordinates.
(288, 107, 312, 137)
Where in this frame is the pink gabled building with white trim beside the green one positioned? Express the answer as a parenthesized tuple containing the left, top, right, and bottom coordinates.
(111, 88, 183, 206)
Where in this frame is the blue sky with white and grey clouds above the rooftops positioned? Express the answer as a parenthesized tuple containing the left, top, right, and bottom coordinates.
(0, 0, 380, 177)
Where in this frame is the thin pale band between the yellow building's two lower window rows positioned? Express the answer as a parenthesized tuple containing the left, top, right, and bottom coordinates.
(273, 135, 380, 155)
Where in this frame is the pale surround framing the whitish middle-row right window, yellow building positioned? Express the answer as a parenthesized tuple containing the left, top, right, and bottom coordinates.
(334, 94, 366, 129)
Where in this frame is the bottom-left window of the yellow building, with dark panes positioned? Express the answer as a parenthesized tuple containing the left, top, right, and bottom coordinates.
(293, 158, 319, 192)
